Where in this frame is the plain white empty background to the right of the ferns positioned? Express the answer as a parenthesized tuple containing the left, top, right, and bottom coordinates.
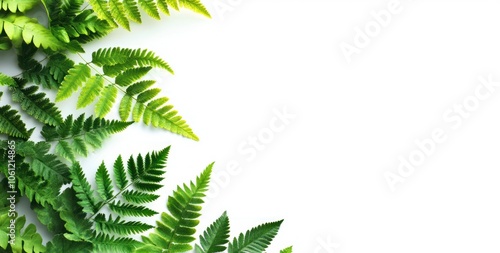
(2, 0, 500, 253)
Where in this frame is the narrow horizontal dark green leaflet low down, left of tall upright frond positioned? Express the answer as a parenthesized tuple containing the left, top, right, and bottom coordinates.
(94, 214, 153, 235)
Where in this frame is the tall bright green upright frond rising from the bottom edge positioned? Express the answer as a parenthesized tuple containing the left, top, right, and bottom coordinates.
(138, 164, 213, 253)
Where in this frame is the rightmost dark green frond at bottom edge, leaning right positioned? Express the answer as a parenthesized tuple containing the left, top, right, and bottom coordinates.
(228, 221, 283, 253)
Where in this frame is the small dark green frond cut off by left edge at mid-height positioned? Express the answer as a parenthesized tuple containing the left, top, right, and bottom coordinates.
(0, 92, 30, 139)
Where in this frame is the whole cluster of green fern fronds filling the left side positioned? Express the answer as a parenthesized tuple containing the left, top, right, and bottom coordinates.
(0, 0, 292, 253)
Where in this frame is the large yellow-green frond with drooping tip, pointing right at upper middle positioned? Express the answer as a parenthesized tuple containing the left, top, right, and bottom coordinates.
(56, 48, 198, 140)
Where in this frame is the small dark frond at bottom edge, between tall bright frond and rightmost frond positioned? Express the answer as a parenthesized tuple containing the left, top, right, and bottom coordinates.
(195, 212, 230, 253)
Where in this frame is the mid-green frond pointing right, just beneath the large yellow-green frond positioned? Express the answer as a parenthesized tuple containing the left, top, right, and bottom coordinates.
(41, 114, 132, 161)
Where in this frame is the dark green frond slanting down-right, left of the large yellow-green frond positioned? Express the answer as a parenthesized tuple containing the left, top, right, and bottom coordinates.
(9, 79, 62, 126)
